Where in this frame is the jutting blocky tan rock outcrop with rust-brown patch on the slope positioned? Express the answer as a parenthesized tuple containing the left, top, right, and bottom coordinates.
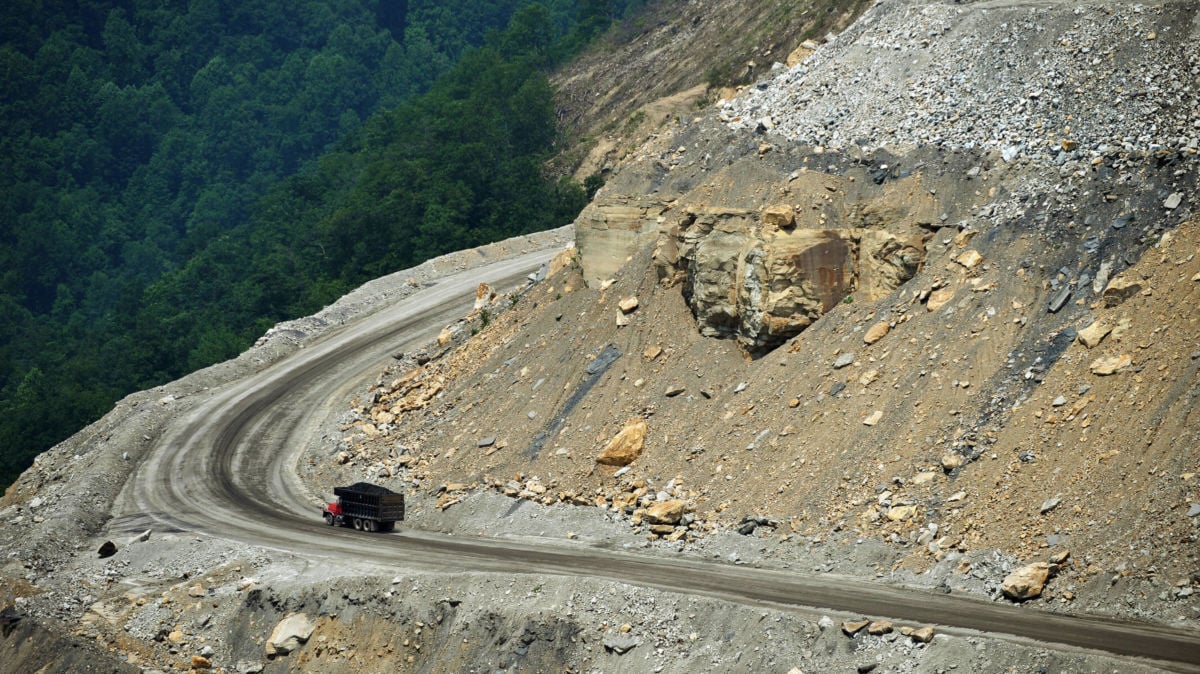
(655, 201, 924, 354)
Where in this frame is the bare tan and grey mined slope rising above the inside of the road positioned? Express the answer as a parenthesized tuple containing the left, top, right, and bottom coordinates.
(313, 2, 1200, 620)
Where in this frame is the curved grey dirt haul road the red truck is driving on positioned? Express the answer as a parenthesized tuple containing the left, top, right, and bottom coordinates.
(133, 251, 1200, 672)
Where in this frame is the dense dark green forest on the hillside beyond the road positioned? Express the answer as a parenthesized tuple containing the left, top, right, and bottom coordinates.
(0, 0, 644, 488)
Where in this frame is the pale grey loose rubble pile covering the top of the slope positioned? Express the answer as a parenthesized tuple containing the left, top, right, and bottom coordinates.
(721, 1, 1200, 164)
